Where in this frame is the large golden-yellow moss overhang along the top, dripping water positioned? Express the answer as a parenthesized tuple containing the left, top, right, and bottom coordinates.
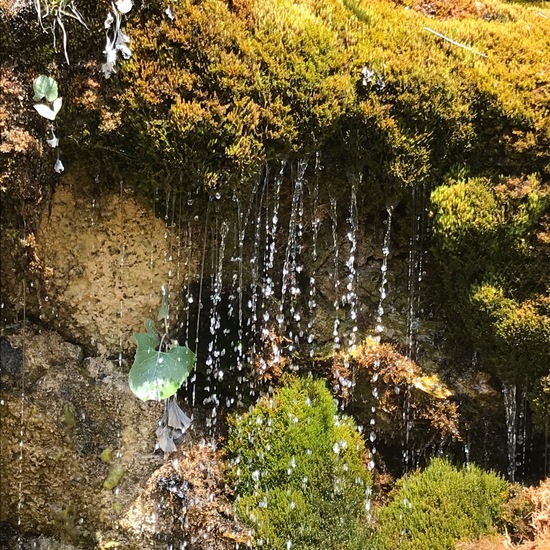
(91, 0, 550, 193)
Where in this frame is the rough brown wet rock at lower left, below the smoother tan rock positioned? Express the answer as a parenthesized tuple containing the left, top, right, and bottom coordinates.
(0, 330, 162, 544)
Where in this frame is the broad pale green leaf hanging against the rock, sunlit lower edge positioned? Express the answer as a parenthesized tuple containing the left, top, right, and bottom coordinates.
(129, 319, 195, 401)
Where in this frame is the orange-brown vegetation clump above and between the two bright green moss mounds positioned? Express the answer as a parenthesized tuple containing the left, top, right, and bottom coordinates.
(332, 338, 461, 467)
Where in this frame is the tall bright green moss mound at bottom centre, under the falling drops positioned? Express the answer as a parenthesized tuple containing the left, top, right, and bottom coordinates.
(226, 379, 371, 549)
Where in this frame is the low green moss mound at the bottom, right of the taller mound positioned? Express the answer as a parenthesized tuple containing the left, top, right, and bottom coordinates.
(373, 459, 508, 550)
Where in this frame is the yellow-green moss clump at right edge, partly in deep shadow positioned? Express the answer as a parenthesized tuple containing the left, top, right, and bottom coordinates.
(432, 176, 550, 432)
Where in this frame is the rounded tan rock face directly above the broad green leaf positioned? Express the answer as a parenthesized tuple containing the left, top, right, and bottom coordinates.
(30, 168, 192, 355)
